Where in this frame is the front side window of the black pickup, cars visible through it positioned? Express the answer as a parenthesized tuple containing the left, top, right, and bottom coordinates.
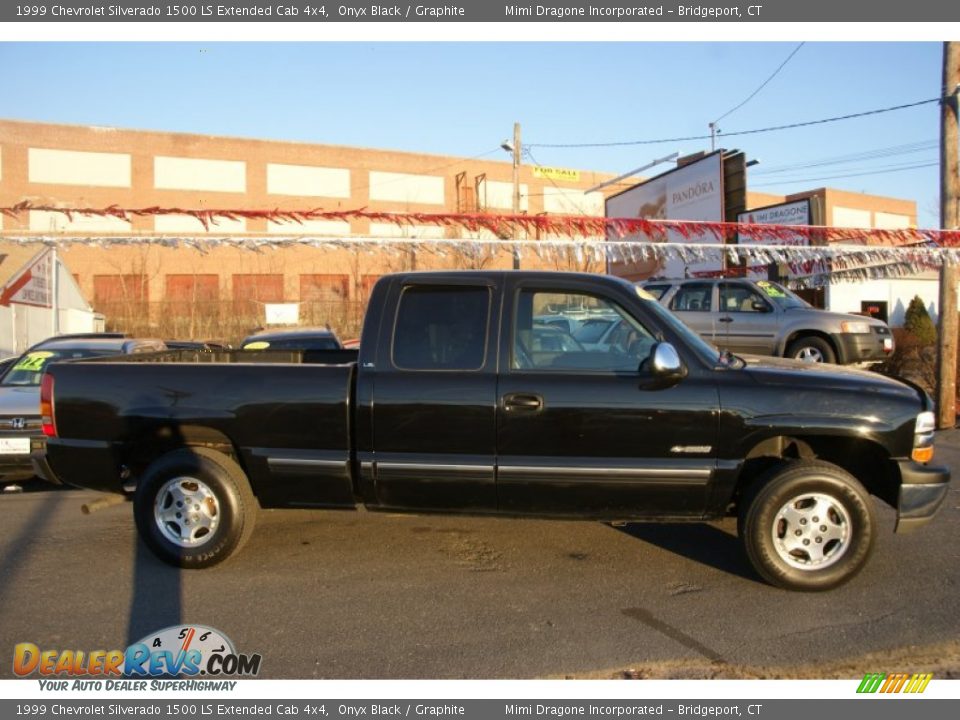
(512, 290, 656, 372)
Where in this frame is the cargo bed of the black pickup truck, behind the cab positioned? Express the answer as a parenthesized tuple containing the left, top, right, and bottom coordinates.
(49, 350, 356, 507)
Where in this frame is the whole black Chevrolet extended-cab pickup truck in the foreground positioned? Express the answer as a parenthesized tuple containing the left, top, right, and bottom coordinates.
(38, 271, 950, 590)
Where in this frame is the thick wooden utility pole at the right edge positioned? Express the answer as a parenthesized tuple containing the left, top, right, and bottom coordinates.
(937, 42, 960, 429)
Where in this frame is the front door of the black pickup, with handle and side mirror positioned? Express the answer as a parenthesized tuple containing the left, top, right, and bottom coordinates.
(497, 275, 718, 519)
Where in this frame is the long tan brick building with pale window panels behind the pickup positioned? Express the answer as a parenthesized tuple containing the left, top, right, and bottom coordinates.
(0, 120, 611, 337)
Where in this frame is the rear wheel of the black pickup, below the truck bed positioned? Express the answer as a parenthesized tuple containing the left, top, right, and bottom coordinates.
(133, 448, 257, 568)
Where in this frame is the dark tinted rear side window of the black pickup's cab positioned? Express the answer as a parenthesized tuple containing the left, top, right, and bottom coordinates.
(393, 286, 490, 370)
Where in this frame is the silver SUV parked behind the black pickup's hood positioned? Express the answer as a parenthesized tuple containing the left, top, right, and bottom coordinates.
(640, 279, 893, 365)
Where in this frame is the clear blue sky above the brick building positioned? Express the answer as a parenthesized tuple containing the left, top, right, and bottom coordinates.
(0, 42, 942, 227)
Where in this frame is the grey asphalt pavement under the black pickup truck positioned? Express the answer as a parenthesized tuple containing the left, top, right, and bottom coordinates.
(0, 430, 960, 678)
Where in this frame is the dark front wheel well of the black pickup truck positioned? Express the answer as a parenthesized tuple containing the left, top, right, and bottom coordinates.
(734, 435, 898, 507)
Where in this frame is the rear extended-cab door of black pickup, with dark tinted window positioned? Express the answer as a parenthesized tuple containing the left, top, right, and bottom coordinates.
(358, 273, 502, 511)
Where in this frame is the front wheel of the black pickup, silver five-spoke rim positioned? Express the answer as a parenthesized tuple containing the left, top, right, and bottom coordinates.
(737, 460, 876, 591)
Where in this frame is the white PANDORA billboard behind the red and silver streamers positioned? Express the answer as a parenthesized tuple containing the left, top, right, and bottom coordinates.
(606, 152, 724, 282)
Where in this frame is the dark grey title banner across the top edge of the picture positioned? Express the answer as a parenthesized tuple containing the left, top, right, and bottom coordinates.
(0, 0, 960, 23)
